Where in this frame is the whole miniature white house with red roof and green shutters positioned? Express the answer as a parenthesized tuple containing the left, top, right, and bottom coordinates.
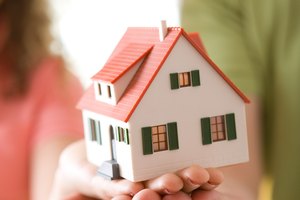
(78, 22, 249, 181)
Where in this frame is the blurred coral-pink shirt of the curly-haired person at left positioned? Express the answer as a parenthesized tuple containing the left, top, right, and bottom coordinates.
(0, 58, 83, 200)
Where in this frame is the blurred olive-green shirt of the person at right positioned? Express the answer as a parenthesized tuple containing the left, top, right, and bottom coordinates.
(182, 0, 300, 200)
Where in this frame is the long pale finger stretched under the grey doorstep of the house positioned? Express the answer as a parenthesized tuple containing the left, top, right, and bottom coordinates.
(91, 176, 144, 199)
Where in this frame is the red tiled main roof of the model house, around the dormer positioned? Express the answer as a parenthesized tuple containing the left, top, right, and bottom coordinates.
(78, 28, 249, 122)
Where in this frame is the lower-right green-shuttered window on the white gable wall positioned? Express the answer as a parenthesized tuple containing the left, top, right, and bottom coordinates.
(201, 113, 237, 145)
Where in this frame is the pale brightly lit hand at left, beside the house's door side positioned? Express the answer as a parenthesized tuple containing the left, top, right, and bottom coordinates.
(50, 140, 144, 200)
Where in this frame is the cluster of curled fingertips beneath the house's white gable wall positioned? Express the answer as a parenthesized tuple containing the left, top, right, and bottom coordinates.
(133, 165, 224, 200)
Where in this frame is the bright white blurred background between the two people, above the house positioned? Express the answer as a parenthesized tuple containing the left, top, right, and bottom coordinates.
(50, 0, 182, 87)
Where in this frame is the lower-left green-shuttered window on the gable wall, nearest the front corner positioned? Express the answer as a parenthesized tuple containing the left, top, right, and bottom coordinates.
(142, 122, 179, 155)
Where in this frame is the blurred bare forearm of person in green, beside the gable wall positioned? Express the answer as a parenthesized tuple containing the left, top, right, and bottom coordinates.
(218, 96, 263, 199)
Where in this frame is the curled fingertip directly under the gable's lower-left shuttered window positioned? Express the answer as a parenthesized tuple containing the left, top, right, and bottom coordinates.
(145, 173, 183, 195)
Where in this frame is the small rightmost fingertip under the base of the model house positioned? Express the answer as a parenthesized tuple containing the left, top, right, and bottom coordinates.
(200, 168, 224, 190)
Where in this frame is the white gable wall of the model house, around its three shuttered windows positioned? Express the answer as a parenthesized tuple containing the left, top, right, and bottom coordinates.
(129, 36, 248, 180)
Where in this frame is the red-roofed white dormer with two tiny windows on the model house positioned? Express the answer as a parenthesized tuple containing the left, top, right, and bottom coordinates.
(93, 43, 154, 105)
